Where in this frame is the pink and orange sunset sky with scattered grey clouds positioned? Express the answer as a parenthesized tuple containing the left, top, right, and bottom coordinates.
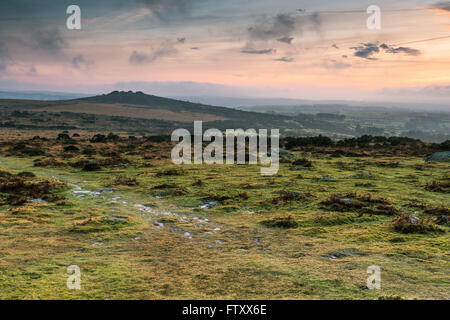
(0, 0, 450, 102)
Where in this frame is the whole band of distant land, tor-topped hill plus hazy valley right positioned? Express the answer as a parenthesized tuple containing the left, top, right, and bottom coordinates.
(0, 91, 450, 142)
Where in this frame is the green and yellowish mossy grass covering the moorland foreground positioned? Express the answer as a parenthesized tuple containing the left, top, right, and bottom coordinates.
(0, 141, 450, 299)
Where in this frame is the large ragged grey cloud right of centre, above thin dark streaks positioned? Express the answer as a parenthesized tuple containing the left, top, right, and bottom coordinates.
(248, 13, 322, 43)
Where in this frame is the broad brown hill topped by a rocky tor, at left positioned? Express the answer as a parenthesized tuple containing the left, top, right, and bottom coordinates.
(0, 91, 298, 134)
